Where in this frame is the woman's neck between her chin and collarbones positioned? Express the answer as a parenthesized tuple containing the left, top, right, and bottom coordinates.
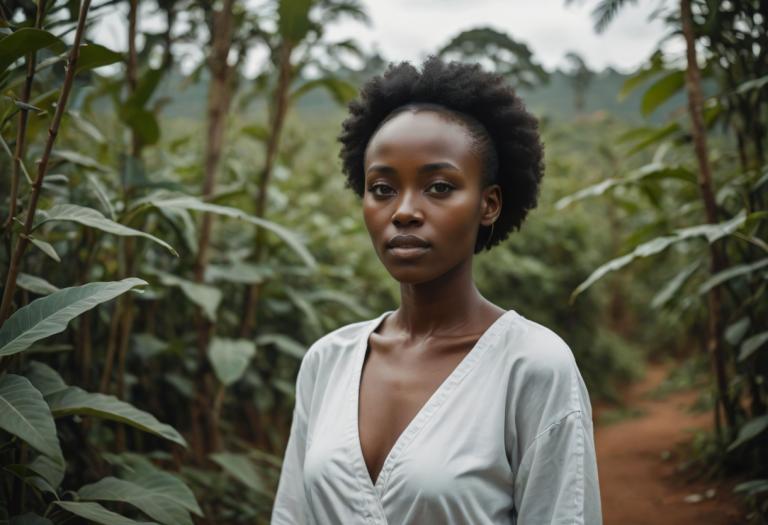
(392, 257, 488, 337)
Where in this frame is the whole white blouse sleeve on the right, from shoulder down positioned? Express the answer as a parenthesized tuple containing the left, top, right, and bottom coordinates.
(512, 328, 602, 525)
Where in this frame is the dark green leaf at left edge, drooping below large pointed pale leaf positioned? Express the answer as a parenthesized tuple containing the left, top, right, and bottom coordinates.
(0, 374, 64, 463)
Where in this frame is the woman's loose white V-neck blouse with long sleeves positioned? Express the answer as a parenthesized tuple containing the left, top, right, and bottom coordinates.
(272, 310, 602, 525)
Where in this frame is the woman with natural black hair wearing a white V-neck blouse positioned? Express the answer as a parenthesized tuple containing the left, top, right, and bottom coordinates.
(272, 58, 602, 525)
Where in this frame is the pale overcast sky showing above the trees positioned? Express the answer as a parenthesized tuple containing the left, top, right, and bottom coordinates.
(94, 0, 681, 71)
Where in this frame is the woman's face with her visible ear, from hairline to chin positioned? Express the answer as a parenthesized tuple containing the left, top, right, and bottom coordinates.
(363, 110, 501, 284)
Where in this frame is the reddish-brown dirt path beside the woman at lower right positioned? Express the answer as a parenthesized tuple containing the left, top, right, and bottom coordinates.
(594, 365, 745, 525)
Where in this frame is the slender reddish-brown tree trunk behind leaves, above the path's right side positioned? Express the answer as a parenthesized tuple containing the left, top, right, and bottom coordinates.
(680, 0, 736, 439)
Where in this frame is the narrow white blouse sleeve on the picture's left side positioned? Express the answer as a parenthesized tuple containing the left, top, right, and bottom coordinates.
(271, 348, 317, 525)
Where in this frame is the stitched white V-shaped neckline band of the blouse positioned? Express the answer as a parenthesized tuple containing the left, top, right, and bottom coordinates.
(350, 310, 515, 497)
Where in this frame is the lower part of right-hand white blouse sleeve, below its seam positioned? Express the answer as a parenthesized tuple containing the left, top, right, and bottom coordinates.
(514, 411, 602, 525)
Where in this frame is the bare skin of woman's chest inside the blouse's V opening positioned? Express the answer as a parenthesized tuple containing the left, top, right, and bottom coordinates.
(358, 338, 476, 483)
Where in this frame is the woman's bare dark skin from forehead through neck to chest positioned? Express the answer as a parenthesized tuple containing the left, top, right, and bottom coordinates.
(358, 110, 505, 484)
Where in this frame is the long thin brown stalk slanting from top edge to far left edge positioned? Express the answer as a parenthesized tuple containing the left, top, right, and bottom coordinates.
(0, 0, 91, 323)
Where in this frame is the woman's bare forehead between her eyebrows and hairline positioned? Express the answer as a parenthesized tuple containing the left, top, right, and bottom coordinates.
(365, 110, 479, 169)
